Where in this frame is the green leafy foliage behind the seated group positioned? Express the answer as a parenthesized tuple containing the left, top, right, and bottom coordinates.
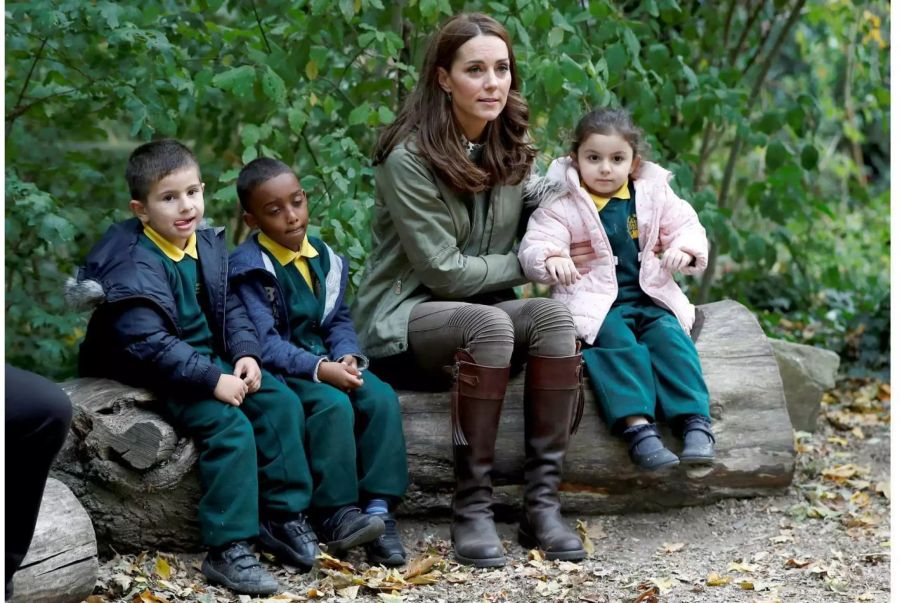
(5, 0, 890, 378)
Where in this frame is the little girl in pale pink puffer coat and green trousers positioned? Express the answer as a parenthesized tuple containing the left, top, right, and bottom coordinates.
(519, 109, 715, 470)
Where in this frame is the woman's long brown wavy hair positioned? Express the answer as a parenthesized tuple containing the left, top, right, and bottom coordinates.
(374, 13, 537, 192)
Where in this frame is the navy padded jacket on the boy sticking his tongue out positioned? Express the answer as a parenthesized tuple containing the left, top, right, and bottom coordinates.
(77, 218, 262, 399)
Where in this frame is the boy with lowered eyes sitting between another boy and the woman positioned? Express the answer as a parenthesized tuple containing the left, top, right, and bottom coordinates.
(230, 158, 408, 565)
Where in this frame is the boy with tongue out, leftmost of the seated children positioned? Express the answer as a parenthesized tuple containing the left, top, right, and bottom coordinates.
(78, 140, 319, 594)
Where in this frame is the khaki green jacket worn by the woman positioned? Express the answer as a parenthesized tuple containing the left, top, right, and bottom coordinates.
(351, 141, 527, 358)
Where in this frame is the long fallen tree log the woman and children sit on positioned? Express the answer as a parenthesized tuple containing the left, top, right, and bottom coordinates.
(56, 301, 794, 551)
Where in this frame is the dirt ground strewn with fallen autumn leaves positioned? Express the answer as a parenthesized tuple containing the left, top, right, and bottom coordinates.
(89, 379, 891, 603)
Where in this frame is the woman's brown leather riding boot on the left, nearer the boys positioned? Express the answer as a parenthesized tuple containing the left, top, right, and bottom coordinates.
(450, 350, 509, 567)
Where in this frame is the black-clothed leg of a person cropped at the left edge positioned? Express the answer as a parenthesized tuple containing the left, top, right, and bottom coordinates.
(6, 364, 72, 598)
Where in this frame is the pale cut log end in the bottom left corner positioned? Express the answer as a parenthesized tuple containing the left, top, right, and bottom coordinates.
(7, 478, 100, 603)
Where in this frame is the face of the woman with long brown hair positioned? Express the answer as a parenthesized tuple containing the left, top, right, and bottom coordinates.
(438, 35, 512, 141)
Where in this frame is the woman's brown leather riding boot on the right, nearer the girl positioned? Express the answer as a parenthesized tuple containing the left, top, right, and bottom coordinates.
(519, 354, 585, 561)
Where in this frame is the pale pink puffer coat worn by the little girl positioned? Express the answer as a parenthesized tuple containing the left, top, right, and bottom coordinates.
(519, 157, 709, 343)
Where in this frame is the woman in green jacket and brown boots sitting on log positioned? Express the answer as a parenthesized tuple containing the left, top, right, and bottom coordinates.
(353, 13, 585, 567)
